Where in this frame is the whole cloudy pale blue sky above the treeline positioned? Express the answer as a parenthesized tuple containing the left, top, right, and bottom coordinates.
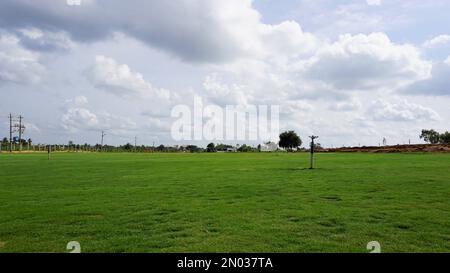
(0, 0, 450, 147)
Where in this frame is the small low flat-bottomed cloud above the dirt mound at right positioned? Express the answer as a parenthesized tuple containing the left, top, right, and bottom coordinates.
(367, 99, 441, 121)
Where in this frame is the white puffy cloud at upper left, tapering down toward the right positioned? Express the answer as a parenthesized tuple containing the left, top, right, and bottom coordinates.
(88, 56, 170, 99)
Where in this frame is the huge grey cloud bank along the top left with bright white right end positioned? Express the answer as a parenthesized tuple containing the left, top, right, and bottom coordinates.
(0, 0, 316, 62)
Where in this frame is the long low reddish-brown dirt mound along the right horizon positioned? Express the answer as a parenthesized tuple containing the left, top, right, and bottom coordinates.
(320, 144, 450, 153)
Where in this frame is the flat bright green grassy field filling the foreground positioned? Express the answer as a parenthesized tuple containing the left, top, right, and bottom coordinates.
(0, 153, 450, 252)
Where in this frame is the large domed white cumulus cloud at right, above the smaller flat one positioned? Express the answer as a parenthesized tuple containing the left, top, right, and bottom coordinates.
(303, 33, 431, 90)
